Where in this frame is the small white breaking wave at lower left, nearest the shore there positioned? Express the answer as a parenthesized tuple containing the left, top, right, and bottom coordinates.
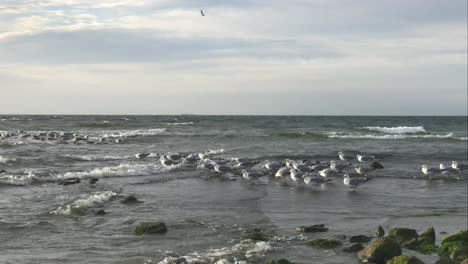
(50, 191, 117, 215)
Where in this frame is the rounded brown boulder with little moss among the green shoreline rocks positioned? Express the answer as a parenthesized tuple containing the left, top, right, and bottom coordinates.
(358, 237, 401, 264)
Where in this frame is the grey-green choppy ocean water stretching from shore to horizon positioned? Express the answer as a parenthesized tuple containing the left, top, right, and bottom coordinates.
(0, 115, 468, 263)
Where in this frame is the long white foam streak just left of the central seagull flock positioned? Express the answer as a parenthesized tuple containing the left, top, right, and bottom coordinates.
(58, 163, 164, 179)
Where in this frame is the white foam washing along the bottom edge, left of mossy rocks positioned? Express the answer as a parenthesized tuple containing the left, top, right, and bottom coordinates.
(158, 240, 274, 264)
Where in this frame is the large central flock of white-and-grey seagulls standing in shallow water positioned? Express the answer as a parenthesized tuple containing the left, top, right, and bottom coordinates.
(155, 152, 384, 191)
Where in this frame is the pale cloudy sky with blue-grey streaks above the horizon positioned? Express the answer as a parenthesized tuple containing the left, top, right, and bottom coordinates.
(0, 0, 468, 115)
